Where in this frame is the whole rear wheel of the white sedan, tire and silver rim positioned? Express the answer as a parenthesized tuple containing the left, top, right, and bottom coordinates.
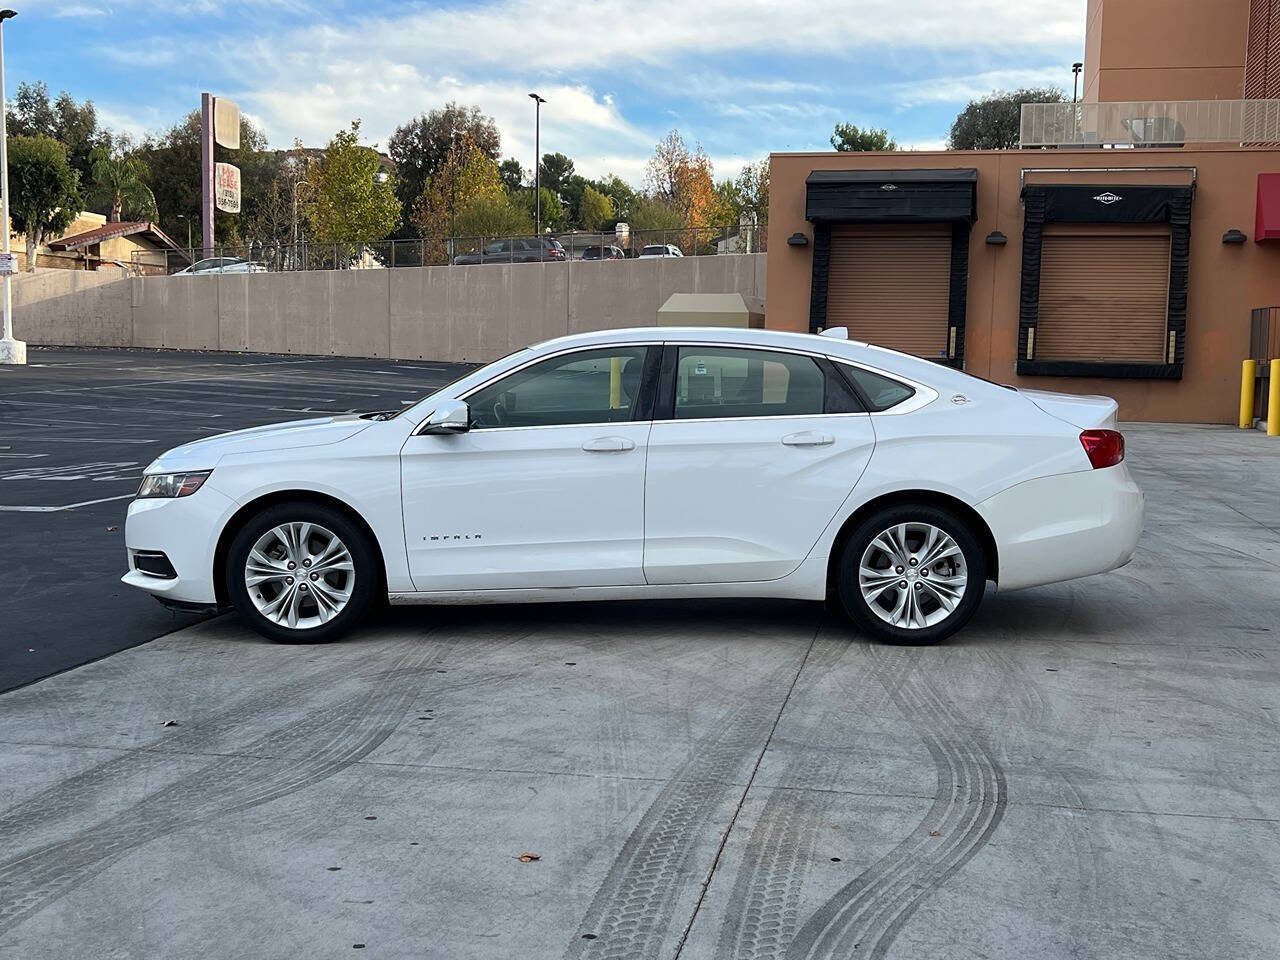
(837, 504, 987, 645)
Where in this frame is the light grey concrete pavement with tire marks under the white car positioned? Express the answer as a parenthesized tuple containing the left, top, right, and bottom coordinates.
(0, 355, 1280, 960)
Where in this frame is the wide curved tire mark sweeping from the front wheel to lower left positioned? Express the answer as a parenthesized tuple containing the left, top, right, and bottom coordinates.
(0, 640, 519, 932)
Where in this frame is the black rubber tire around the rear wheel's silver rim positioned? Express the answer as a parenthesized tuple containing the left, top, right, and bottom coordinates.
(836, 503, 987, 646)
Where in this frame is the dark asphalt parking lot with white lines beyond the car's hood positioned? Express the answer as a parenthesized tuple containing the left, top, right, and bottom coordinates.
(0, 348, 466, 690)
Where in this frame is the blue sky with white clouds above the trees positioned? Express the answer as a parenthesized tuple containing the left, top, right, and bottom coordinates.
(15, 0, 1085, 183)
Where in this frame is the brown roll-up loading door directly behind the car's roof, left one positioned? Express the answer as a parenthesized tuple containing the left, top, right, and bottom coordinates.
(827, 224, 951, 360)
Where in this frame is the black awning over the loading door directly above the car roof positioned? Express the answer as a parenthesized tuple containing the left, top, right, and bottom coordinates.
(805, 168, 978, 223)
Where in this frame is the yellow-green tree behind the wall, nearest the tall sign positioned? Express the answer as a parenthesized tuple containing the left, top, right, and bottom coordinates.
(301, 120, 401, 253)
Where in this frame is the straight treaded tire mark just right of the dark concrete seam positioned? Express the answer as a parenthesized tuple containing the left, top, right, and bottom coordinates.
(716, 637, 850, 960)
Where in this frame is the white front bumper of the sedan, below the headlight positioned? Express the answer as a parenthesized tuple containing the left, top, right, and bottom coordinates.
(120, 484, 236, 607)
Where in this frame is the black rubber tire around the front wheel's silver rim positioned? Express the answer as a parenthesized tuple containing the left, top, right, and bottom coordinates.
(225, 502, 383, 644)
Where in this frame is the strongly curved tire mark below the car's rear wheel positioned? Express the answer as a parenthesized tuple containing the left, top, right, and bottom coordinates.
(787, 645, 1007, 960)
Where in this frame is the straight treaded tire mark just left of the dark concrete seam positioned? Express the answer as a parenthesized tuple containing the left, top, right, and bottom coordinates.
(564, 663, 795, 960)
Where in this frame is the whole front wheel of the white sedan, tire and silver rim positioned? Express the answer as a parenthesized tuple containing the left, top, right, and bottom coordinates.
(227, 503, 381, 644)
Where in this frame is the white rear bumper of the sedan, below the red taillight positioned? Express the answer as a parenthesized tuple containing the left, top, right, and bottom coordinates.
(975, 463, 1143, 590)
